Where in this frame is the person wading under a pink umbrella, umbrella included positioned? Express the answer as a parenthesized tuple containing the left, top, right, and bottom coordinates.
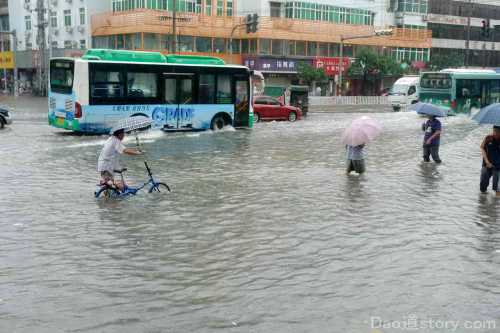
(342, 116, 382, 174)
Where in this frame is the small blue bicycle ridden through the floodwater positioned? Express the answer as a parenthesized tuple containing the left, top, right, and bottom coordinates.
(94, 161, 171, 198)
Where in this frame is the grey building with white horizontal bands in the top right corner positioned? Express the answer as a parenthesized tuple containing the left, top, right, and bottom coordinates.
(427, 0, 500, 67)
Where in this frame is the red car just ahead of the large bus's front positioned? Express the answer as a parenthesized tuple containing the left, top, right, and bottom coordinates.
(253, 96, 302, 122)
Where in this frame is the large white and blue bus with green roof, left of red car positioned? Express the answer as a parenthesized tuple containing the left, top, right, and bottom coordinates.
(48, 49, 253, 134)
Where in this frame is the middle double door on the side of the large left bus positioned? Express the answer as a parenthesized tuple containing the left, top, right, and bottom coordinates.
(163, 73, 194, 130)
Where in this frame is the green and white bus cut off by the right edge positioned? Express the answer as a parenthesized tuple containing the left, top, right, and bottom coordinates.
(419, 69, 500, 114)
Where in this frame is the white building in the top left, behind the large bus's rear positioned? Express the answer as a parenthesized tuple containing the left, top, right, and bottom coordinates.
(8, 0, 111, 94)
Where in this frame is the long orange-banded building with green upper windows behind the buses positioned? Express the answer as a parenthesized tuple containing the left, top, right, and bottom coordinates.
(92, 0, 431, 91)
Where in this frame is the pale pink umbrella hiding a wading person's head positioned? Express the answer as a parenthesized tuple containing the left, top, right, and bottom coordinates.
(342, 116, 382, 146)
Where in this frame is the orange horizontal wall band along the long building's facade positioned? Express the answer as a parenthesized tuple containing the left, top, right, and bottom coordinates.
(92, 9, 432, 48)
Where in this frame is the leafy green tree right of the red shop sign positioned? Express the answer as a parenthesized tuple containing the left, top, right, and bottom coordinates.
(347, 48, 404, 95)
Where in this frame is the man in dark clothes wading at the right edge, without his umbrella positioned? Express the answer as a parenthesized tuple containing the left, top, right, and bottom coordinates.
(479, 126, 500, 195)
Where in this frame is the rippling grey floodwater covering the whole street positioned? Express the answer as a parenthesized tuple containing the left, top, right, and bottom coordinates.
(0, 99, 500, 333)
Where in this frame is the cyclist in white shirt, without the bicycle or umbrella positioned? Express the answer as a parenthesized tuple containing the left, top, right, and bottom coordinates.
(97, 130, 142, 191)
